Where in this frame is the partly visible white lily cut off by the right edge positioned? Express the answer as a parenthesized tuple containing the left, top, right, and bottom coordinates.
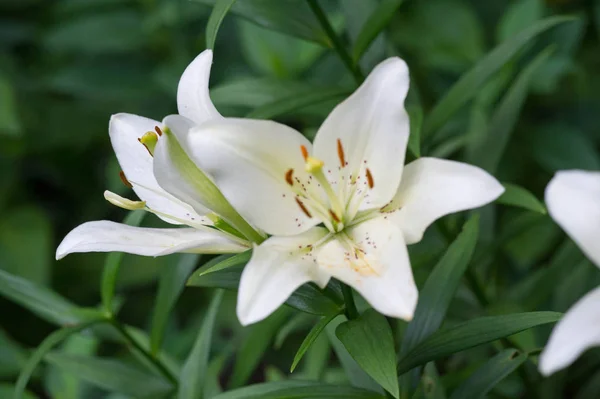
(539, 170, 600, 375)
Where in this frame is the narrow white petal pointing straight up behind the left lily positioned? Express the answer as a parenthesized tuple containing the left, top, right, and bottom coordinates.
(177, 50, 221, 124)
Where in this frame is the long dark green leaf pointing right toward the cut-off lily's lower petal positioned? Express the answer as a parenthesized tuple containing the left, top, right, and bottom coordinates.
(398, 312, 562, 374)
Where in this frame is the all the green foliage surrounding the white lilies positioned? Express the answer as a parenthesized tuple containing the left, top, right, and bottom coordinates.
(0, 0, 600, 399)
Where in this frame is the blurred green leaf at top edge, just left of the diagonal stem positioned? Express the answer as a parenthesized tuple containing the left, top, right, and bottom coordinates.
(196, 0, 330, 47)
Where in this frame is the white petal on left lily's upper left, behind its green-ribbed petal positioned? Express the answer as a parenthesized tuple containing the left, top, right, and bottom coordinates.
(109, 114, 200, 224)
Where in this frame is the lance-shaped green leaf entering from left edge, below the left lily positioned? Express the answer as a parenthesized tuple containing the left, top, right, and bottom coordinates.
(0, 270, 102, 325)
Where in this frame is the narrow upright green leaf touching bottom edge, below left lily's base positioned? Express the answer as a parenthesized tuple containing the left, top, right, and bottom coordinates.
(177, 290, 223, 399)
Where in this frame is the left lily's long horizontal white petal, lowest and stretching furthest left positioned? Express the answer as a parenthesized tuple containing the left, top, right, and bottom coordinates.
(56, 220, 248, 259)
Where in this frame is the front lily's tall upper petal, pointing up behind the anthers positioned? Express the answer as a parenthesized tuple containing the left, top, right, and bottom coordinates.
(314, 57, 410, 209)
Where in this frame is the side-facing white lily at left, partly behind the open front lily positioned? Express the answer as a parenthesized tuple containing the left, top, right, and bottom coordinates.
(56, 50, 262, 259)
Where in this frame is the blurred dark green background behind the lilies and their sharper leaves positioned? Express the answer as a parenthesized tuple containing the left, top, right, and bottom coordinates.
(0, 0, 600, 397)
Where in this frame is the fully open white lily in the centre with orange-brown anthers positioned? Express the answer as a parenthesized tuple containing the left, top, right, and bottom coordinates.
(182, 58, 504, 324)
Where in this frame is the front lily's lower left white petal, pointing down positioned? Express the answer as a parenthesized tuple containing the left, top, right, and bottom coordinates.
(237, 227, 330, 325)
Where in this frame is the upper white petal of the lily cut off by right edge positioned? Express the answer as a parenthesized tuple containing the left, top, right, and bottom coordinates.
(546, 170, 600, 267)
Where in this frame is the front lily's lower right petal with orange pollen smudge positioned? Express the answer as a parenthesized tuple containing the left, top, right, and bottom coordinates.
(317, 217, 418, 320)
